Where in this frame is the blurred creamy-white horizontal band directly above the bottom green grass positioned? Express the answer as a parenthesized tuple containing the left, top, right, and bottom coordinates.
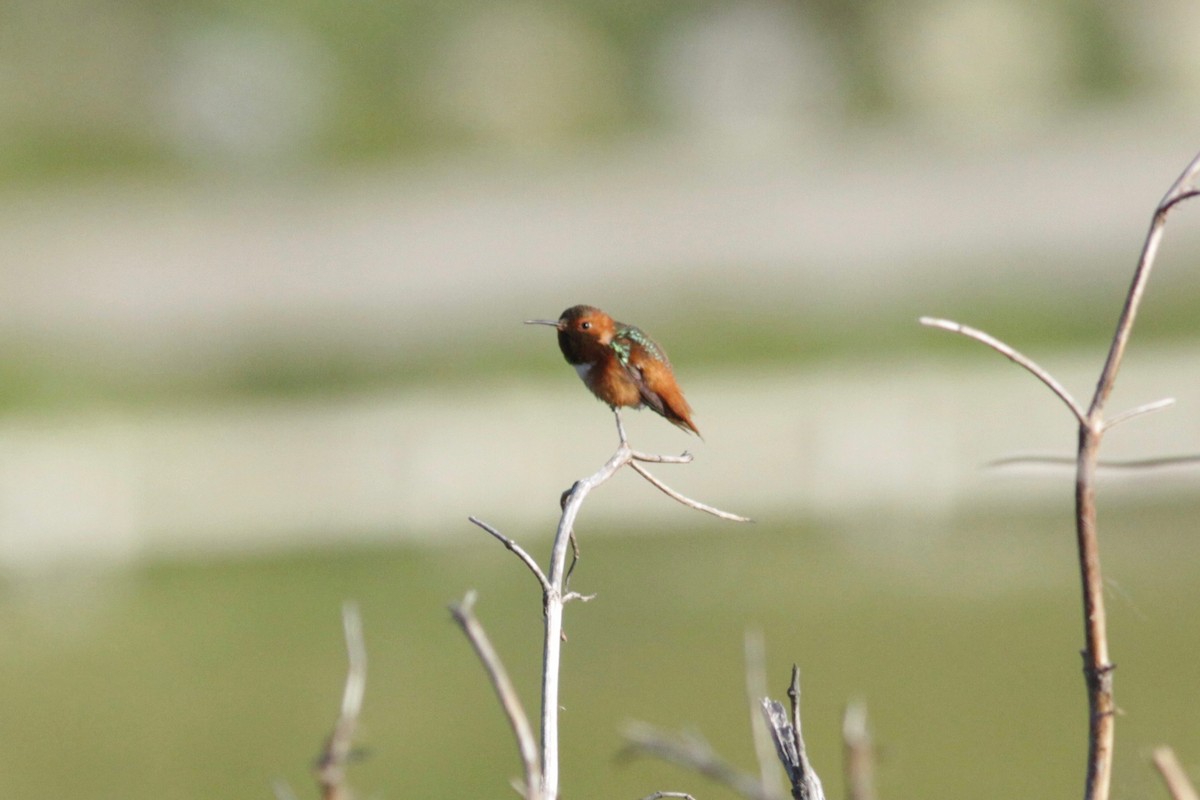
(0, 347, 1200, 569)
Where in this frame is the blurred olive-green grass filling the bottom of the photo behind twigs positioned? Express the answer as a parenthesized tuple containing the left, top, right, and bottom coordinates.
(0, 506, 1200, 800)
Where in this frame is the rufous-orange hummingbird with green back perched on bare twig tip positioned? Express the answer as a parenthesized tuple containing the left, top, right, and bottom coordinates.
(526, 306, 700, 435)
